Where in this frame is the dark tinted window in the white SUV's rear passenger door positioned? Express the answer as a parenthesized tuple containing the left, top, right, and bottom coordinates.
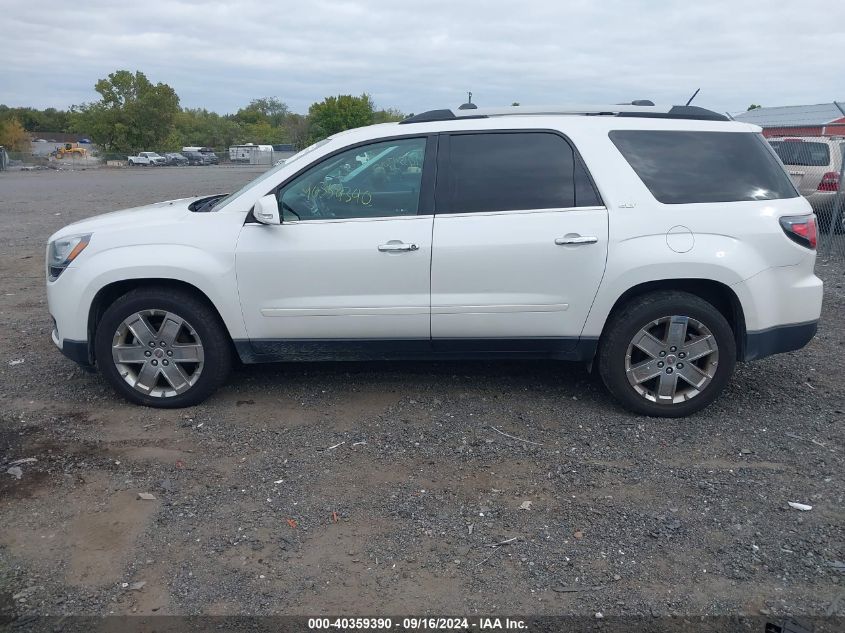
(445, 132, 601, 213)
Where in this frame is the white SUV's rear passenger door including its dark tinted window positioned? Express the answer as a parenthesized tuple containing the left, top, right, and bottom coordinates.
(431, 131, 608, 355)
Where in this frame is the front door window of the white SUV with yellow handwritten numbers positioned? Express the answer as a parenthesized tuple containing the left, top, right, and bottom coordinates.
(278, 138, 426, 222)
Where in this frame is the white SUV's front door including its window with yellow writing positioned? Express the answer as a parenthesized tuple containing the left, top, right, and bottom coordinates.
(236, 137, 434, 359)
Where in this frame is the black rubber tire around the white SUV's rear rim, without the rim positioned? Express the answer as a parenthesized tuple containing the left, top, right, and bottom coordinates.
(598, 291, 736, 418)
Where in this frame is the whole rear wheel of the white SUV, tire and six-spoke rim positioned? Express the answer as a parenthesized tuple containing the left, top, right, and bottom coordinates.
(598, 291, 736, 418)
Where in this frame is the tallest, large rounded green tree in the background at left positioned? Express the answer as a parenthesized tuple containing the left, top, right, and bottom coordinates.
(72, 70, 179, 153)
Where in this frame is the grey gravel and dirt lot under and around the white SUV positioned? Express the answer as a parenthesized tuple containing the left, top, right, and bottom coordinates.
(0, 168, 845, 624)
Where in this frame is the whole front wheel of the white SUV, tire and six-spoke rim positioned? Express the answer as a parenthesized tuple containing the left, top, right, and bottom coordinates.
(94, 289, 232, 408)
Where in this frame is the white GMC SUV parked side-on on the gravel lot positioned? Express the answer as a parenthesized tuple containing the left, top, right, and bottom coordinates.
(42, 105, 822, 416)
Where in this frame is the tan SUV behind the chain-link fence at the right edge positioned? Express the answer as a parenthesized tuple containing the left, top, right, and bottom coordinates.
(769, 136, 845, 233)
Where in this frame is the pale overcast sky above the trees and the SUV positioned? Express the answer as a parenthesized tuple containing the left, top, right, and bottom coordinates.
(0, 0, 845, 113)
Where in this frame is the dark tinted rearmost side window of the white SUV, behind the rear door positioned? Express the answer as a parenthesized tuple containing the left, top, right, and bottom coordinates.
(610, 130, 798, 204)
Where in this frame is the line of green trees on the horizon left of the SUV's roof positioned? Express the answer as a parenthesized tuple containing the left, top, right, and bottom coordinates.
(0, 70, 404, 154)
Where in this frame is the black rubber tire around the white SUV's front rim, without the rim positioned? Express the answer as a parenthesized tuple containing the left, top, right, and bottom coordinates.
(94, 288, 232, 409)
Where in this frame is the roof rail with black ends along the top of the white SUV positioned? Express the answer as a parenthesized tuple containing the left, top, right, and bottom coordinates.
(400, 101, 729, 124)
